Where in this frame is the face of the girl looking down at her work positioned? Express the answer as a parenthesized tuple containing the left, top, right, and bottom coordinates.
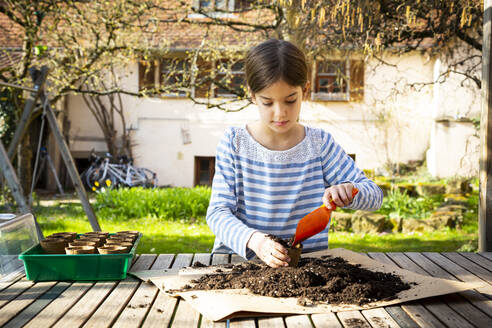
(251, 80, 307, 133)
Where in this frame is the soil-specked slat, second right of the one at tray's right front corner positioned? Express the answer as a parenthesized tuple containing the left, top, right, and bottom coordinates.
(112, 254, 174, 328)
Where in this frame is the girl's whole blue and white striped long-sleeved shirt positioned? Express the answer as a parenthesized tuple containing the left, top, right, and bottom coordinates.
(207, 127, 383, 259)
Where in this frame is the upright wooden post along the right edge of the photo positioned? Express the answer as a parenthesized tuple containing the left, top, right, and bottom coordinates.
(478, 0, 492, 252)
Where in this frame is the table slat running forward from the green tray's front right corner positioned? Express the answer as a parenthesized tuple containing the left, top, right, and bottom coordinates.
(53, 256, 140, 327)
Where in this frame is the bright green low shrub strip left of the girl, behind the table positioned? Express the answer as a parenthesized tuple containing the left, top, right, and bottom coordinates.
(94, 186, 211, 221)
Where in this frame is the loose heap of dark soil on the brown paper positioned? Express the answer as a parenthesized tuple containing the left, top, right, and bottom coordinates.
(185, 256, 410, 306)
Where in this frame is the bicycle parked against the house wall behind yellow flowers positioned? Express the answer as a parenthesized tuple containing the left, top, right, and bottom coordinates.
(85, 152, 157, 191)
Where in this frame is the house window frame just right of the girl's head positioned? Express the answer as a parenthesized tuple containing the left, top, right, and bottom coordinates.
(311, 57, 351, 101)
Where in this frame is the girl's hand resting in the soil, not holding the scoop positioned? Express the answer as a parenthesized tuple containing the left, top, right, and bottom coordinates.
(247, 231, 290, 268)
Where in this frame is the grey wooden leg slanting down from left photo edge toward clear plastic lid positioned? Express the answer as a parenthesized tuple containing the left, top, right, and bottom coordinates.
(0, 140, 43, 240)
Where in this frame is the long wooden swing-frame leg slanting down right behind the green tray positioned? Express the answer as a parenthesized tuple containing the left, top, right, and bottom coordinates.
(40, 92, 101, 231)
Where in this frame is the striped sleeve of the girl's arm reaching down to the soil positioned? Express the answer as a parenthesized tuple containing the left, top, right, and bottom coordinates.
(206, 129, 256, 258)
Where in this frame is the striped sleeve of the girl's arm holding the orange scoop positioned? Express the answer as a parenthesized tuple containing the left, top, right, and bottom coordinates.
(321, 132, 383, 211)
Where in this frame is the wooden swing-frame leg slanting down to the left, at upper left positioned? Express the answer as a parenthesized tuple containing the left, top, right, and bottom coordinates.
(7, 66, 48, 161)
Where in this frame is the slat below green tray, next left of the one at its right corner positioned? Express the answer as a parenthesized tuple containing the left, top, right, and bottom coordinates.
(24, 282, 94, 328)
